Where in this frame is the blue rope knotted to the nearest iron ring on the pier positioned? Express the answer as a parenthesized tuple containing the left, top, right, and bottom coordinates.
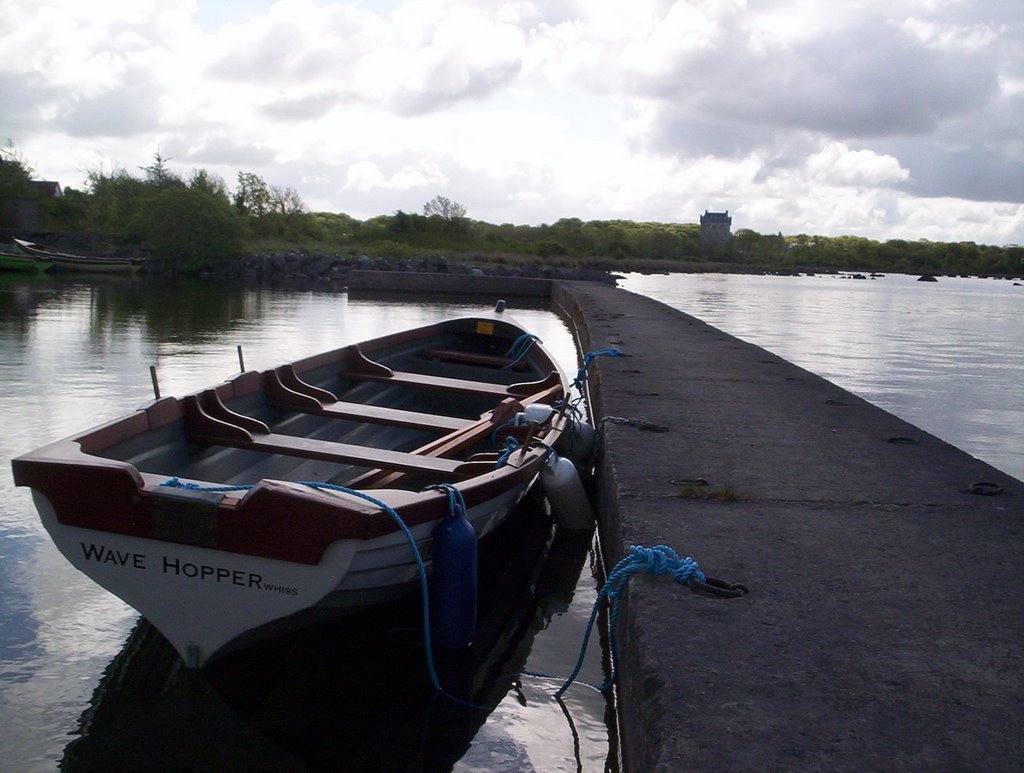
(555, 545, 706, 698)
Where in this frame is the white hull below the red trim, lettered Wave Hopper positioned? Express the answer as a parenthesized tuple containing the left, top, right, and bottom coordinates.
(33, 477, 528, 669)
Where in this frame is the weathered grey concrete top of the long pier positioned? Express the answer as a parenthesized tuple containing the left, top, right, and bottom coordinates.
(554, 283, 1024, 772)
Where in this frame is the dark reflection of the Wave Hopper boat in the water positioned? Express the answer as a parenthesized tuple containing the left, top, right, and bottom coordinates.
(61, 497, 590, 773)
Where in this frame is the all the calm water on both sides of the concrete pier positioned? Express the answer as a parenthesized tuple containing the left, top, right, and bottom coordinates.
(6, 274, 1024, 771)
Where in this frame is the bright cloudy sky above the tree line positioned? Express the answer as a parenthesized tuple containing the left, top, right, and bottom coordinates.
(0, 0, 1024, 245)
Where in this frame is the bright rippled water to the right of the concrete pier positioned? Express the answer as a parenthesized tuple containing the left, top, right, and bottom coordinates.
(620, 274, 1024, 479)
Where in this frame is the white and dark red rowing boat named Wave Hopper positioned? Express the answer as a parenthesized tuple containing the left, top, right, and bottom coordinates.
(12, 311, 569, 668)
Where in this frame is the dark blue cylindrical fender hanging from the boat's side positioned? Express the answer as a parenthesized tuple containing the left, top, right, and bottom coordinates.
(430, 503, 476, 647)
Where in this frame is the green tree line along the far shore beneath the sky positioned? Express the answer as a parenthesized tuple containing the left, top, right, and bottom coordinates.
(0, 143, 1024, 275)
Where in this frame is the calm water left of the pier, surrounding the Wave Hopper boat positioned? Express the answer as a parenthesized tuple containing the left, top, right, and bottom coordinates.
(0, 274, 609, 771)
